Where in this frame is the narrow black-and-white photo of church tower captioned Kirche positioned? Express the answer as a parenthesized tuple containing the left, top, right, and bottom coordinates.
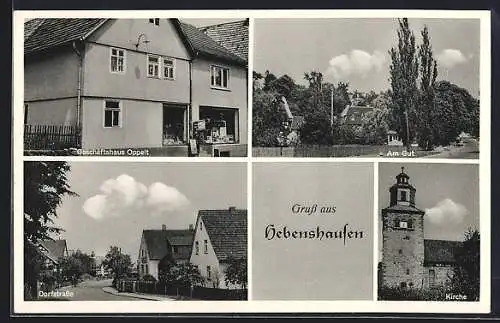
(378, 163, 480, 302)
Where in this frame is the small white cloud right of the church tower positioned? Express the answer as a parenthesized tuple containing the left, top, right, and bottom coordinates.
(425, 198, 469, 226)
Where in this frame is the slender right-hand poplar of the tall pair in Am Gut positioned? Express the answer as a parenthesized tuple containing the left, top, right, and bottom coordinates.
(417, 26, 438, 150)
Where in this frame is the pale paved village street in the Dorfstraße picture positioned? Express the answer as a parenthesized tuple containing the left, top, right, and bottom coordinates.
(60, 279, 140, 301)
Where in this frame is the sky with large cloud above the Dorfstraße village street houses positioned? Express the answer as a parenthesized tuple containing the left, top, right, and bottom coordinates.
(47, 161, 247, 260)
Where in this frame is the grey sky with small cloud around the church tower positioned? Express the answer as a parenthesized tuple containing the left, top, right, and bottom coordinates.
(379, 163, 479, 260)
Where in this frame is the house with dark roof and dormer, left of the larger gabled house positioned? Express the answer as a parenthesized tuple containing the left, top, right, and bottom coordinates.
(137, 225, 194, 279)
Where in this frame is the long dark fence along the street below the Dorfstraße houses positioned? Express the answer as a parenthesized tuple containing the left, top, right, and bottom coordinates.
(116, 280, 247, 300)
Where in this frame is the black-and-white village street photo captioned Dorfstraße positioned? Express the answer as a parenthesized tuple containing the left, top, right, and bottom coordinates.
(24, 161, 247, 301)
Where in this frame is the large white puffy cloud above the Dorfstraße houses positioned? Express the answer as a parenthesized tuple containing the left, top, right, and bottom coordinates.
(82, 174, 189, 220)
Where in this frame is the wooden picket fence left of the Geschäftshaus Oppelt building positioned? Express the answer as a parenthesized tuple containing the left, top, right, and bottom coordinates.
(24, 125, 82, 150)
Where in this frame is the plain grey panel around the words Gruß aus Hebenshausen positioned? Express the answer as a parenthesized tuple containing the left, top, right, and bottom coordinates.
(252, 162, 373, 300)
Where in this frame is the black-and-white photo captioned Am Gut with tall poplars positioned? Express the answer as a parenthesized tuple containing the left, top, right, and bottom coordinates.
(252, 17, 480, 159)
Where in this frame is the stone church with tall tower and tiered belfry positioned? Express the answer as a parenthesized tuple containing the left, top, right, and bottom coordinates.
(379, 167, 462, 289)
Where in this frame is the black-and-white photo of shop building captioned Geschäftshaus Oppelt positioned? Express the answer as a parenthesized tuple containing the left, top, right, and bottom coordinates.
(24, 18, 249, 157)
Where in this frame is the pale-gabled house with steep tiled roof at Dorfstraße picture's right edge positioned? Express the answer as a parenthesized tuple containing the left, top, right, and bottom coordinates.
(190, 207, 248, 289)
